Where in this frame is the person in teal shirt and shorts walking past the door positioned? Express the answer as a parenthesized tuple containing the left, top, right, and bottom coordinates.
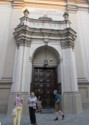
(54, 90, 64, 121)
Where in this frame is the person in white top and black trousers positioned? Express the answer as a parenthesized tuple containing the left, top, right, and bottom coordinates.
(28, 92, 37, 125)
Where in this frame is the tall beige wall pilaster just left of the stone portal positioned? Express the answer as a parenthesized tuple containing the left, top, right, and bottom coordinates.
(3, 8, 23, 78)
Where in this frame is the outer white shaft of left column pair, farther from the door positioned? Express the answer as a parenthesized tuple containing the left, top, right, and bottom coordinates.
(11, 46, 25, 92)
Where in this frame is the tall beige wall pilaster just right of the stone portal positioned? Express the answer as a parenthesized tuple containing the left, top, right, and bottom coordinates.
(69, 11, 84, 79)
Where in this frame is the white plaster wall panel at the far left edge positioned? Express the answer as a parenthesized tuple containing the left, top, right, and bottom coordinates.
(0, 5, 12, 79)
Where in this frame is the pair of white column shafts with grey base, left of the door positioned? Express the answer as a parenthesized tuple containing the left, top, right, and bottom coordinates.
(8, 44, 32, 115)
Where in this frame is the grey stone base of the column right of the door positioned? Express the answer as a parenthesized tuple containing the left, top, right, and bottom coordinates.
(62, 92, 82, 114)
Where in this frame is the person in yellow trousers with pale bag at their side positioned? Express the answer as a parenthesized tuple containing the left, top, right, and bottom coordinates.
(13, 92, 23, 125)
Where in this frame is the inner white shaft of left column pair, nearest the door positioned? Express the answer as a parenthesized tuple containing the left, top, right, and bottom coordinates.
(21, 47, 32, 93)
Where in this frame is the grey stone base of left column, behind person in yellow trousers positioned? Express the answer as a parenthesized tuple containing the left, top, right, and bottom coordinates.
(7, 93, 29, 116)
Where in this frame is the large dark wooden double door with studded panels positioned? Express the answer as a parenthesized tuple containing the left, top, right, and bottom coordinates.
(31, 67, 58, 108)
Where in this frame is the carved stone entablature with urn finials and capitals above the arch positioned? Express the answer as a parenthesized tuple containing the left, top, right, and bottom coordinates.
(14, 9, 76, 48)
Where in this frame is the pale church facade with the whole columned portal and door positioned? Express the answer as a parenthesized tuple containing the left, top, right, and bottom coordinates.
(0, 0, 89, 114)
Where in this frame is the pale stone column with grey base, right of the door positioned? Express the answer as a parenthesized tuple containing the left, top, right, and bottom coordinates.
(61, 41, 82, 113)
